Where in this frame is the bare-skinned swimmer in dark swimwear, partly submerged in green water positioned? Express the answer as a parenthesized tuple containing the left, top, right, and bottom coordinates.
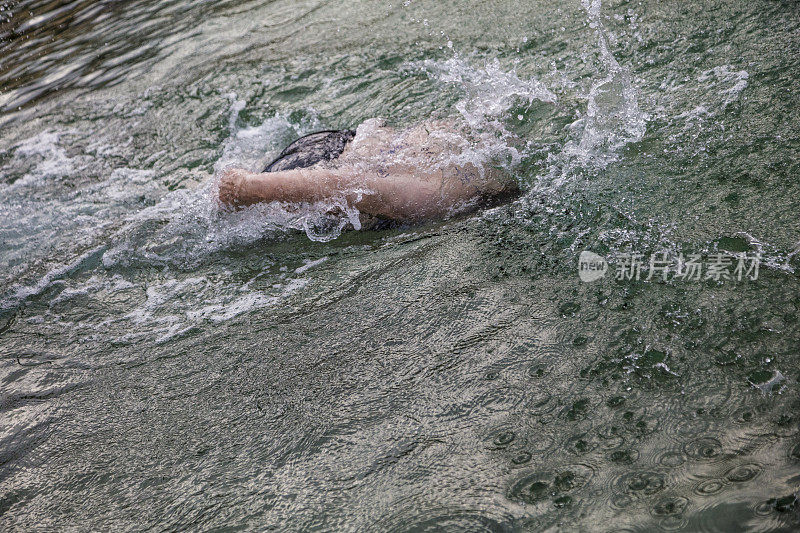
(219, 119, 517, 222)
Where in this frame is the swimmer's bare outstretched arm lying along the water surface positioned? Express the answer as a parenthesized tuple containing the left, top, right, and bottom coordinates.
(219, 167, 507, 220)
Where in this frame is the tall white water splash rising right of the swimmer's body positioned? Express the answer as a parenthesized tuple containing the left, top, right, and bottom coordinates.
(408, 0, 648, 192)
